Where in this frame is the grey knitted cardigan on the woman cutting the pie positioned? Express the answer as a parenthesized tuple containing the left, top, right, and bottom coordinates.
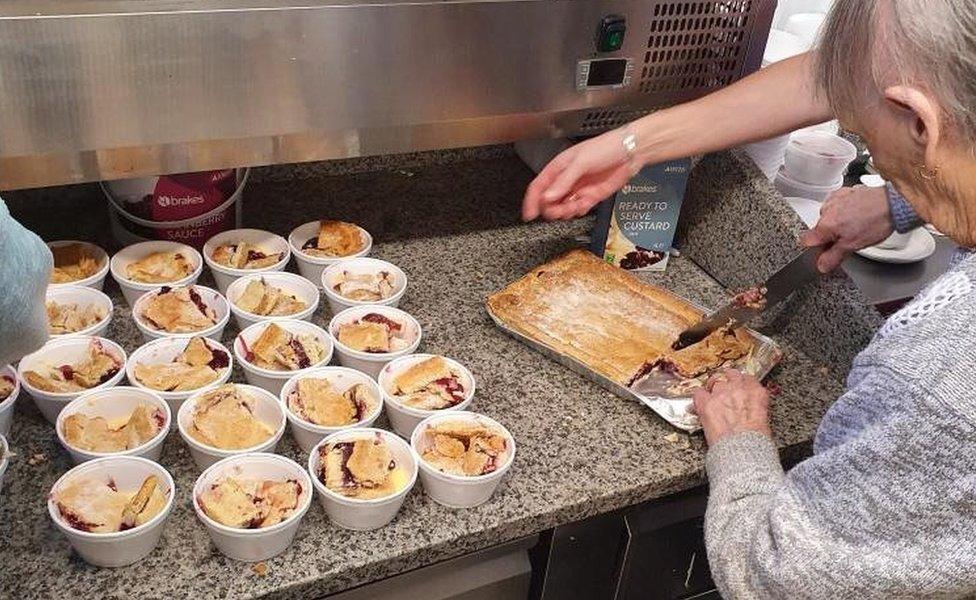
(705, 254, 976, 599)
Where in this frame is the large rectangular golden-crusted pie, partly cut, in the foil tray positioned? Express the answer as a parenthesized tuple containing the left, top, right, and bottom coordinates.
(488, 250, 755, 386)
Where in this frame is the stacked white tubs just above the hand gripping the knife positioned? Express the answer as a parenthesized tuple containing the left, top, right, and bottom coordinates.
(774, 131, 857, 200)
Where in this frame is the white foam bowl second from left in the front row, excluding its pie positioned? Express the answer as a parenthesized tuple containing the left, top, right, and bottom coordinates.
(193, 453, 313, 562)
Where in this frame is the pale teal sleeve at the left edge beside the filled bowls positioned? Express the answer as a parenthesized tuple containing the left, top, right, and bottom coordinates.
(0, 199, 54, 365)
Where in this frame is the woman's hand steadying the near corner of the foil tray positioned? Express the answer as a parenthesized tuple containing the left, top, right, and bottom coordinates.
(693, 369, 772, 445)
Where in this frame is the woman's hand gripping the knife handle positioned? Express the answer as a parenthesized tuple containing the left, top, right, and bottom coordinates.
(800, 185, 895, 273)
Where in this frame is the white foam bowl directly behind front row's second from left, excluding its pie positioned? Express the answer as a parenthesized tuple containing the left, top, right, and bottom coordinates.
(176, 383, 286, 469)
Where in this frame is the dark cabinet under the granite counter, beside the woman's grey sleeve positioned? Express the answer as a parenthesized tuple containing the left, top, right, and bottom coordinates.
(533, 488, 720, 600)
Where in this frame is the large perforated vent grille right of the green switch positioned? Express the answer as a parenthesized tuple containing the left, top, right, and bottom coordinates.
(640, 0, 760, 94)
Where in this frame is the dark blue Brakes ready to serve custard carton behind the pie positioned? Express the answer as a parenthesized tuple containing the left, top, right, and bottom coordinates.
(590, 159, 691, 271)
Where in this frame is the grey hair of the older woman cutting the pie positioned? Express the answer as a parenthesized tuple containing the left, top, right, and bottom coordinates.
(815, 0, 976, 144)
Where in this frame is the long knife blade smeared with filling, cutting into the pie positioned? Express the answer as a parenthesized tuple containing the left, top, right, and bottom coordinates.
(672, 246, 823, 350)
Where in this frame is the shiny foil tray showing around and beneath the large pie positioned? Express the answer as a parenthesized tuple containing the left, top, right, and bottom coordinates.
(485, 294, 783, 433)
